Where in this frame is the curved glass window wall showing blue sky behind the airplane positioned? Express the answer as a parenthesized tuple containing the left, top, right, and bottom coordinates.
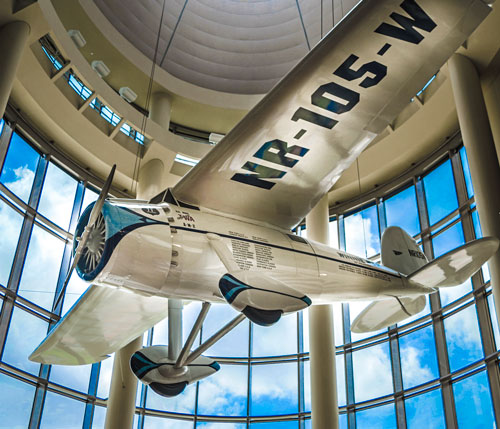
(0, 115, 500, 429)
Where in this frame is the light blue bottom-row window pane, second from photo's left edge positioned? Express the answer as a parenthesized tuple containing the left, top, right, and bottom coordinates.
(40, 392, 85, 429)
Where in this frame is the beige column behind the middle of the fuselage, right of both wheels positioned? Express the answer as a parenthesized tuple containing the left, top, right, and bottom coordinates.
(306, 195, 339, 429)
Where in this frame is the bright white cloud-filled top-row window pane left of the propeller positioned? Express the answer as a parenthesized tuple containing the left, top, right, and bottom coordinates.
(38, 163, 78, 230)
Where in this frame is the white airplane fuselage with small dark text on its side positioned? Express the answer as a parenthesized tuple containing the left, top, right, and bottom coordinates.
(80, 199, 425, 304)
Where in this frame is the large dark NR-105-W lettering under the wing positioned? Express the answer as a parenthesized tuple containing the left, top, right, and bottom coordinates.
(231, 0, 436, 190)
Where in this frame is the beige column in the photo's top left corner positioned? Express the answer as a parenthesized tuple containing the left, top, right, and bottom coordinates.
(0, 21, 31, 118)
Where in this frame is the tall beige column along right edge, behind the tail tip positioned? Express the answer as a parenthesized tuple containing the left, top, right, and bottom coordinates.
(448, 54, 500, 320)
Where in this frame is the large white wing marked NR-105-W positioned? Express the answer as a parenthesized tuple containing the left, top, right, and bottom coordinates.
(172, 0, 490, 229)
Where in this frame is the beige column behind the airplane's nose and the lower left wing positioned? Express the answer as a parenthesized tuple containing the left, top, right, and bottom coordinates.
(104, 159, 164, 429)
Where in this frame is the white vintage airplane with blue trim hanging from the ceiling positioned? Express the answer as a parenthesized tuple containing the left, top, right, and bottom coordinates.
(30, 0, 499, 397)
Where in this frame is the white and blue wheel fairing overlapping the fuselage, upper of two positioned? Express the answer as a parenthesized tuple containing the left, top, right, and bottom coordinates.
(219, 271, 311, 326)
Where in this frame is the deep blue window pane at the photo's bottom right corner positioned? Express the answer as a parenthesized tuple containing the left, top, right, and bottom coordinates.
(453, 372, 496, 429)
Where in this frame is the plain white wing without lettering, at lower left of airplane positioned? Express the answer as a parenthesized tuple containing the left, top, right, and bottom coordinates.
(29, 285, 168, 365)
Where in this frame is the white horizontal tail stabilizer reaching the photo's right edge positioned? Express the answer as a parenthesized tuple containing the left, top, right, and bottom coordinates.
(408, 237, 499, 288)
